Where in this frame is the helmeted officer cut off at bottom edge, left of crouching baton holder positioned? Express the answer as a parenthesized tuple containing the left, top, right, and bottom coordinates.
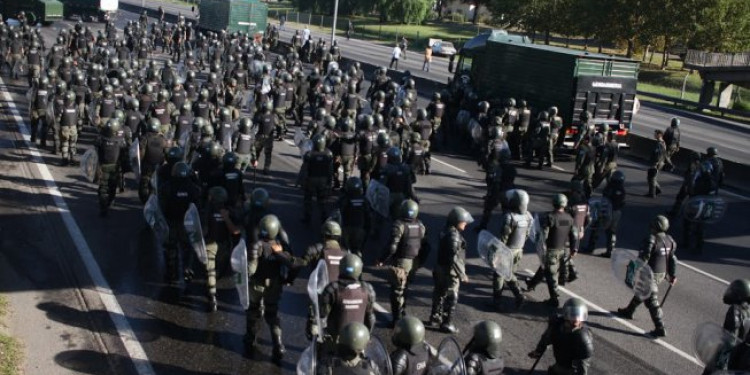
(464, 320, 505, 375)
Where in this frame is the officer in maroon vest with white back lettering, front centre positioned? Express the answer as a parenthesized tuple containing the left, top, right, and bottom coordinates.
(320, 254, 375, 342)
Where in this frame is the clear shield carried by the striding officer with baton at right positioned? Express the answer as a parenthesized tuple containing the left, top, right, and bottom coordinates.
(612, 249, 656, 301)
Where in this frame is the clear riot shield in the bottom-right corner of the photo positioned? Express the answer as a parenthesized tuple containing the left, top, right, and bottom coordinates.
(693, 322, 739, 371)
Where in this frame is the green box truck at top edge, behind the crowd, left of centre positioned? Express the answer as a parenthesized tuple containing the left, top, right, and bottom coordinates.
(198, 0, 268, 35)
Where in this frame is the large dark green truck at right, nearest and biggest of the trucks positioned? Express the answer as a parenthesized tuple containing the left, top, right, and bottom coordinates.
(448, 30, 639, 146)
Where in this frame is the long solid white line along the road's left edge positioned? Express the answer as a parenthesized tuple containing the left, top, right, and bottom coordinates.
(0, 78, 155, 375)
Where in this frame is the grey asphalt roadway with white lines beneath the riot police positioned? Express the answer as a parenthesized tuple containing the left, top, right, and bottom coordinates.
(0, 7, 750, 375)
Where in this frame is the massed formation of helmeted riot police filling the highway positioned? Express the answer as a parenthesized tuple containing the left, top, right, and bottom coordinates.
(0, 7, 750, 374)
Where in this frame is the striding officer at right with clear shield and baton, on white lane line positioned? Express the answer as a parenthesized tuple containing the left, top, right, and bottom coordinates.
(617, 215, 677, 337)
